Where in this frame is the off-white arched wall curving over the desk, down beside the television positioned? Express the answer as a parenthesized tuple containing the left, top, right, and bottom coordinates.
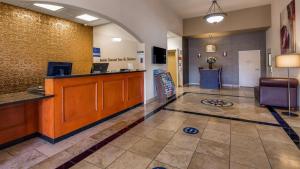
(30, 0, 183, 100)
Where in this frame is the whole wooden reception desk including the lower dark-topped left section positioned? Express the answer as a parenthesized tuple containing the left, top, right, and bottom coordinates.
(0, 71, 144, 149)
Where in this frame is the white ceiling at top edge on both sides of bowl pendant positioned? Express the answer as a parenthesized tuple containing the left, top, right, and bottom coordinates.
(162, 0, 271, 18)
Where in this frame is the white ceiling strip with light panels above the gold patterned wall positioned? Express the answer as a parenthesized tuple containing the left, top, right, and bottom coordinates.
(0, 0, 110, 26)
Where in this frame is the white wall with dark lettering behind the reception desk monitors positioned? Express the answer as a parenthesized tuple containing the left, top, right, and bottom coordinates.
(93, 23, 143, 71)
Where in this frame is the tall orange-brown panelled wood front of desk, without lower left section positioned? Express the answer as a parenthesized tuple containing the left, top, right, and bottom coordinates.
(39, 71, 144, 142)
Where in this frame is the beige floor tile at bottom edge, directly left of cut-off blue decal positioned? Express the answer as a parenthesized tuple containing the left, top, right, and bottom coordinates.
(108, 152, 151, 169)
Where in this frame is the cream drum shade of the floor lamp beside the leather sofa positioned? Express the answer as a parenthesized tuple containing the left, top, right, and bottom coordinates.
(275, 53, 300, 68)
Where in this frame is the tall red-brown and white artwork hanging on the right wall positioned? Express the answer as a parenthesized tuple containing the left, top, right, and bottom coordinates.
(280, 0, 296, 54)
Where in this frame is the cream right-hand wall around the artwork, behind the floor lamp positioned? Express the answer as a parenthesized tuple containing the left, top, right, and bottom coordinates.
(267, 0, 300, 105)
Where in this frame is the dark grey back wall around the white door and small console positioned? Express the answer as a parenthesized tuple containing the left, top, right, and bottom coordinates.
(184, 31, 266, 85)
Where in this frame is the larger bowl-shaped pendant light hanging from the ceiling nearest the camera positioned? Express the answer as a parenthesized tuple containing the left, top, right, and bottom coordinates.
(203, 0, 227, 24)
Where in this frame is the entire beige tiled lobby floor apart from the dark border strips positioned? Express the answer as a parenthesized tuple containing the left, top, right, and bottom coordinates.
(0, 87, 300, 169)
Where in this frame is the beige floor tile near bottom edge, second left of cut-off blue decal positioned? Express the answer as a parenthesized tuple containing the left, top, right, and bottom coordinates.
(84, 145, 125, 168)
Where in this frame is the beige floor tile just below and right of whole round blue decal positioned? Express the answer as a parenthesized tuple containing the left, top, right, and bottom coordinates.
(196, 139, 230, 160)
